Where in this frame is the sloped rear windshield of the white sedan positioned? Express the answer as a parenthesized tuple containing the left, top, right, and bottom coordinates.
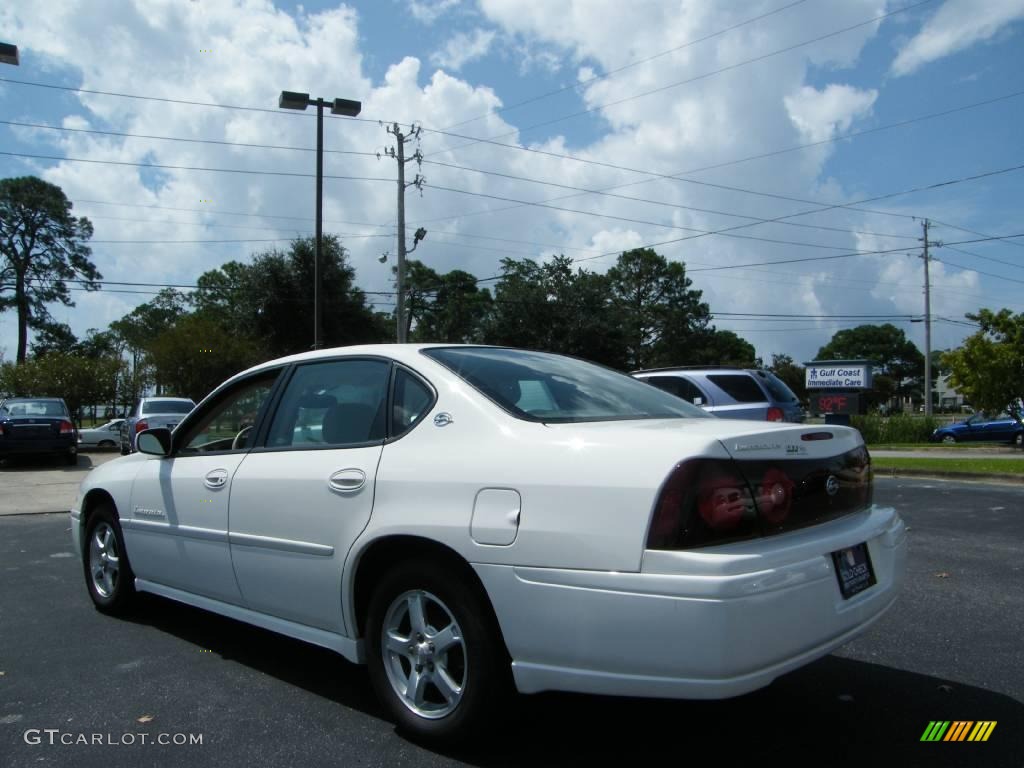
(423, 347, 711, 423)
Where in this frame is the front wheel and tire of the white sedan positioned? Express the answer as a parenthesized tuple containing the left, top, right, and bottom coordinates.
(82, 504, 135, 615)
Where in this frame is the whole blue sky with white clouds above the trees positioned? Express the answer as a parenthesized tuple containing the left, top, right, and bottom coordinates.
(0, 0, 1024, 359)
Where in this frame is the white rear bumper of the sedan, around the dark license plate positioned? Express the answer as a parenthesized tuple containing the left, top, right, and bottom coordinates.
(474, 508, 906, 698)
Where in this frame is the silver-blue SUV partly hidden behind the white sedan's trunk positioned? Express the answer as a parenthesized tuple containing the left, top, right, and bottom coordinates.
(633, 368, 807, 423)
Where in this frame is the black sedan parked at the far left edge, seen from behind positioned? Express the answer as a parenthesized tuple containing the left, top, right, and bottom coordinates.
(0, 397, 78, 465)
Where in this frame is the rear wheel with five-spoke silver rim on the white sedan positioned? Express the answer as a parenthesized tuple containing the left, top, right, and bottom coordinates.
(366, 559, 512, 743)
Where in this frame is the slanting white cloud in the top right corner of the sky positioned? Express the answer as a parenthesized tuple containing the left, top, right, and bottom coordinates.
(892, 0, 1024, 76)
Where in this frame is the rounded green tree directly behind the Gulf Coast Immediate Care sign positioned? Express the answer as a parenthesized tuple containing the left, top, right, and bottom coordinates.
(815, 323, 925, 405)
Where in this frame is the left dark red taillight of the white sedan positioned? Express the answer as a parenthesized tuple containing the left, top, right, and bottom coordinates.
(647, 459, 760, 549)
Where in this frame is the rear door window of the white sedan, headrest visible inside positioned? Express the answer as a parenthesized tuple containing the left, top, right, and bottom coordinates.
(266, 359, 391, 447)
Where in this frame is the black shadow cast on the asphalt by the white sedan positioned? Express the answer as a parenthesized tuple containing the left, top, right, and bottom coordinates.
(123, 595, 1024, 768)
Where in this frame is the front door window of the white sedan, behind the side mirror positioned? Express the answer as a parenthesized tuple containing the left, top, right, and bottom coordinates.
(179, 371, 281, 456)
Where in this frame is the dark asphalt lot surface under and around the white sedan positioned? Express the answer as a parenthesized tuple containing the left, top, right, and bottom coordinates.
(0, 475, 1024, 766)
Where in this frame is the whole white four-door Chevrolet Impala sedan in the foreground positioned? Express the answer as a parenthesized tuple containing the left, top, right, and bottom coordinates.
(72, 345, 906, 740)
